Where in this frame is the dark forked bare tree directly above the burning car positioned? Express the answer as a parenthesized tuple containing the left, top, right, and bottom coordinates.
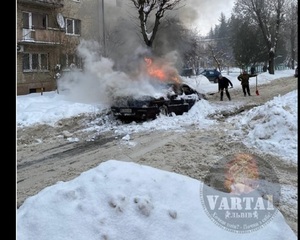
(131, 0, 184, 48)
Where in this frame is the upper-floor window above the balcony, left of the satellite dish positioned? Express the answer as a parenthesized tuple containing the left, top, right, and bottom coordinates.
(23, 12, 47, 29)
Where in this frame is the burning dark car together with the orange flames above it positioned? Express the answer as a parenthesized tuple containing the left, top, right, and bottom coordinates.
(111, 57, 203, 122)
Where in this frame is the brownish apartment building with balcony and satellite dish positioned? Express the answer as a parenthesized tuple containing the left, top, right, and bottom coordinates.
(16, 0, 100, 95)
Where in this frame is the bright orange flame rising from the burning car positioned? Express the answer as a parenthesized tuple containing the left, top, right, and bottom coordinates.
(144, 57, 180, 83)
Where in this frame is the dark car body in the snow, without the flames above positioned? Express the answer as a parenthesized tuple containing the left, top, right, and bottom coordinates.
(111, 83, 205, 122)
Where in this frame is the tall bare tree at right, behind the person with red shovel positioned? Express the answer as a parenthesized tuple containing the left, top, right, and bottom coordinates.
(236, 0, 289, 74)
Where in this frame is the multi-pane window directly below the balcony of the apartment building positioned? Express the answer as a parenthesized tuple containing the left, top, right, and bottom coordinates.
(23, 53, 49, 72)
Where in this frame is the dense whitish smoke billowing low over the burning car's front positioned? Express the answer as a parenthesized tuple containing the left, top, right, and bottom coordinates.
(59, 41, 177, 106)
